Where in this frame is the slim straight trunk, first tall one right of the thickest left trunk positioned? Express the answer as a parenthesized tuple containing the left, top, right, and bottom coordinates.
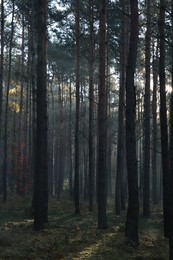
(74, 0, 80, 214)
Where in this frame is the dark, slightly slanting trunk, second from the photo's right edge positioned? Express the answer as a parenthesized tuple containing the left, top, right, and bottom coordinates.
(159, 0, 170, 237)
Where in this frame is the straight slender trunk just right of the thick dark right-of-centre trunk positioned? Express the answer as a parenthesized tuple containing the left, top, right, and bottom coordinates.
(143, 0, 151, 217)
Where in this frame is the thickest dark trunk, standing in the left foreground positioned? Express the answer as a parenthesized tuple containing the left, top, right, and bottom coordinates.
(34, 0, 48, 230)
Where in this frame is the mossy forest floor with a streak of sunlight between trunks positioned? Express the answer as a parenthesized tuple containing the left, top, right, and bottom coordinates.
(0, 197, 169, 260)
